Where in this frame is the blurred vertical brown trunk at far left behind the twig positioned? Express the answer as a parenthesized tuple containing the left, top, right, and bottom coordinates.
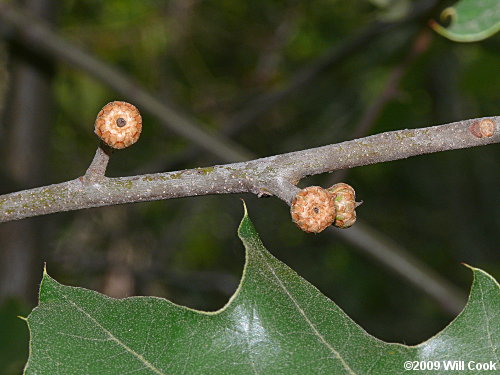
(0, 0, 55, 308)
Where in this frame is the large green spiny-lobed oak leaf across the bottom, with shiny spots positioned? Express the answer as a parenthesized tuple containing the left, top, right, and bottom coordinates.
(25, 210, 500, 375)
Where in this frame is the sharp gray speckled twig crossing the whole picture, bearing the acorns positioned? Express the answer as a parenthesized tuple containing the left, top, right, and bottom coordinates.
(0, 116, 500, 222)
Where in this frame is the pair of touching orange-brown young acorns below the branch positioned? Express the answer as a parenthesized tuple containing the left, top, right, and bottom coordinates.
(290, 182, 359, 233)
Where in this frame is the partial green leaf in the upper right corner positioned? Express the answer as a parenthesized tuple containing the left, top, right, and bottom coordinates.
(430, 0, 500, 42)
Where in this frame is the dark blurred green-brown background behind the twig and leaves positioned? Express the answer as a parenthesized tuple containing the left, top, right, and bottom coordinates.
(0, 0, 500, 374)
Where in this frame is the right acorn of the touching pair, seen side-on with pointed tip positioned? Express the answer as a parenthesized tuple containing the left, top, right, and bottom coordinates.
(327, 182, 359, 228)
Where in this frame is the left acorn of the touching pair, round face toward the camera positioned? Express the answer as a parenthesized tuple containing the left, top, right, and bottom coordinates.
(290, 186, 335, 233)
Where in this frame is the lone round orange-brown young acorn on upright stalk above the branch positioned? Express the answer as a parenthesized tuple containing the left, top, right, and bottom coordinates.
(95, 101, 142, 149)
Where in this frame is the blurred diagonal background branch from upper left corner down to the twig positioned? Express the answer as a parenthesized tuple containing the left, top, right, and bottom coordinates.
(0, 3, 252, 161)
